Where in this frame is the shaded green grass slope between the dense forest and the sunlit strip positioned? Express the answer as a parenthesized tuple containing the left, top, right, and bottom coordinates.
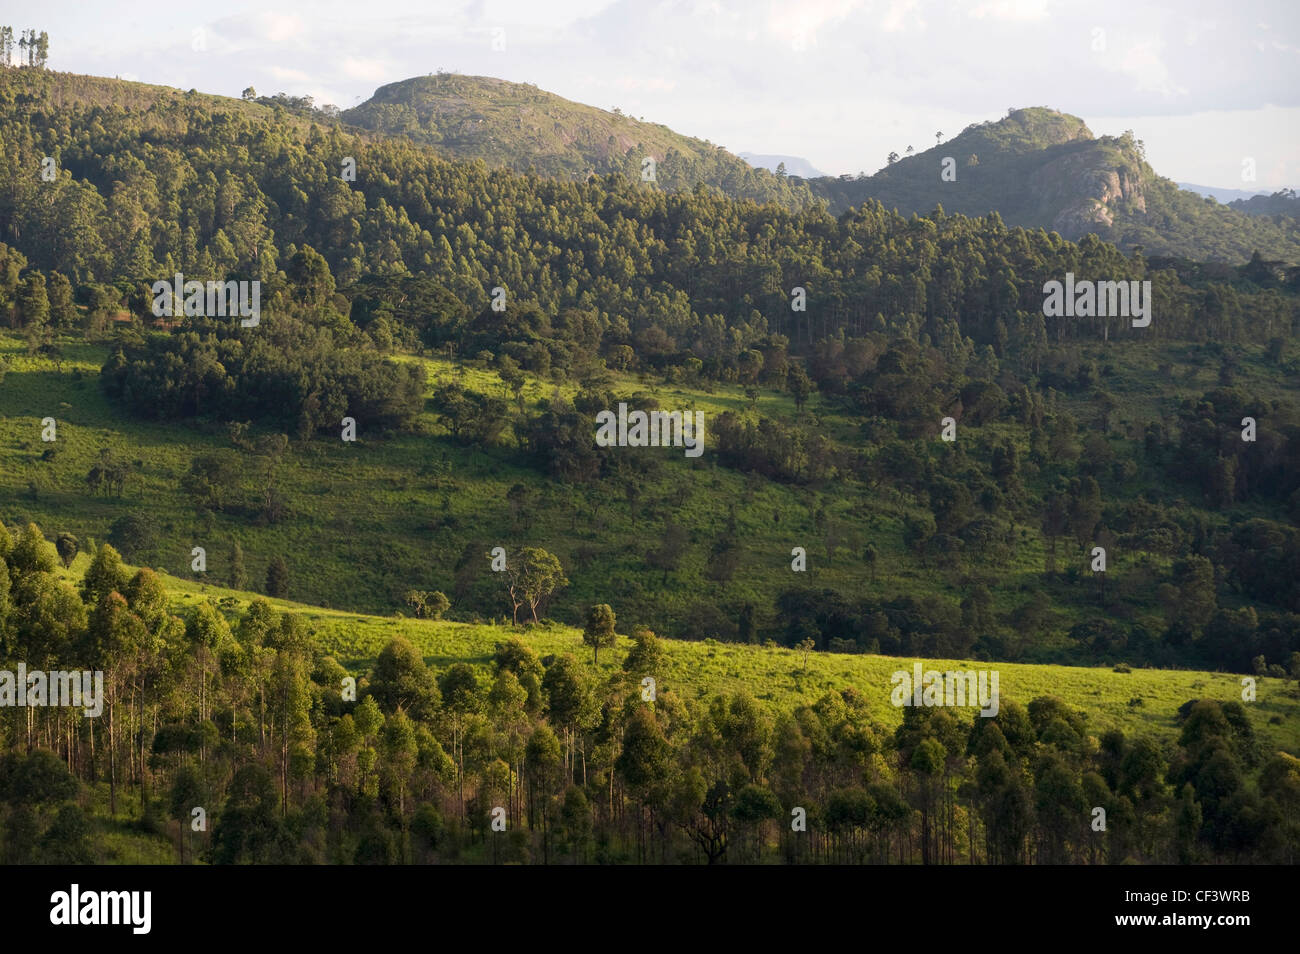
(0, 328, 1296, 662)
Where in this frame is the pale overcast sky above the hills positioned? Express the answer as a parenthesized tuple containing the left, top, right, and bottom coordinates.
(30, 0, 1300, 191)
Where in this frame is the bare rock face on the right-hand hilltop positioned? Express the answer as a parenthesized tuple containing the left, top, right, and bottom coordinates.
(1028, 149, 1147, 240)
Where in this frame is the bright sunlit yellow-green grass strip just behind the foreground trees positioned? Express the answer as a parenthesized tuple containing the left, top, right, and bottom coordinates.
(50, 554, 1300, 754)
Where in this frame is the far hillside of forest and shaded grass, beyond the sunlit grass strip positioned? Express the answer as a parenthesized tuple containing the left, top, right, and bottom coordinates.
(0, 65, 1300, 671)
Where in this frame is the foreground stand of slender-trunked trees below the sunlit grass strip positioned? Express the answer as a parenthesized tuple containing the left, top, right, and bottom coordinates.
(0, 530, 1300, 864)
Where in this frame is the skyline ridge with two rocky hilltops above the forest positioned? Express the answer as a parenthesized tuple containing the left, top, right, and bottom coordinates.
(8, 70, 1300, 264)
